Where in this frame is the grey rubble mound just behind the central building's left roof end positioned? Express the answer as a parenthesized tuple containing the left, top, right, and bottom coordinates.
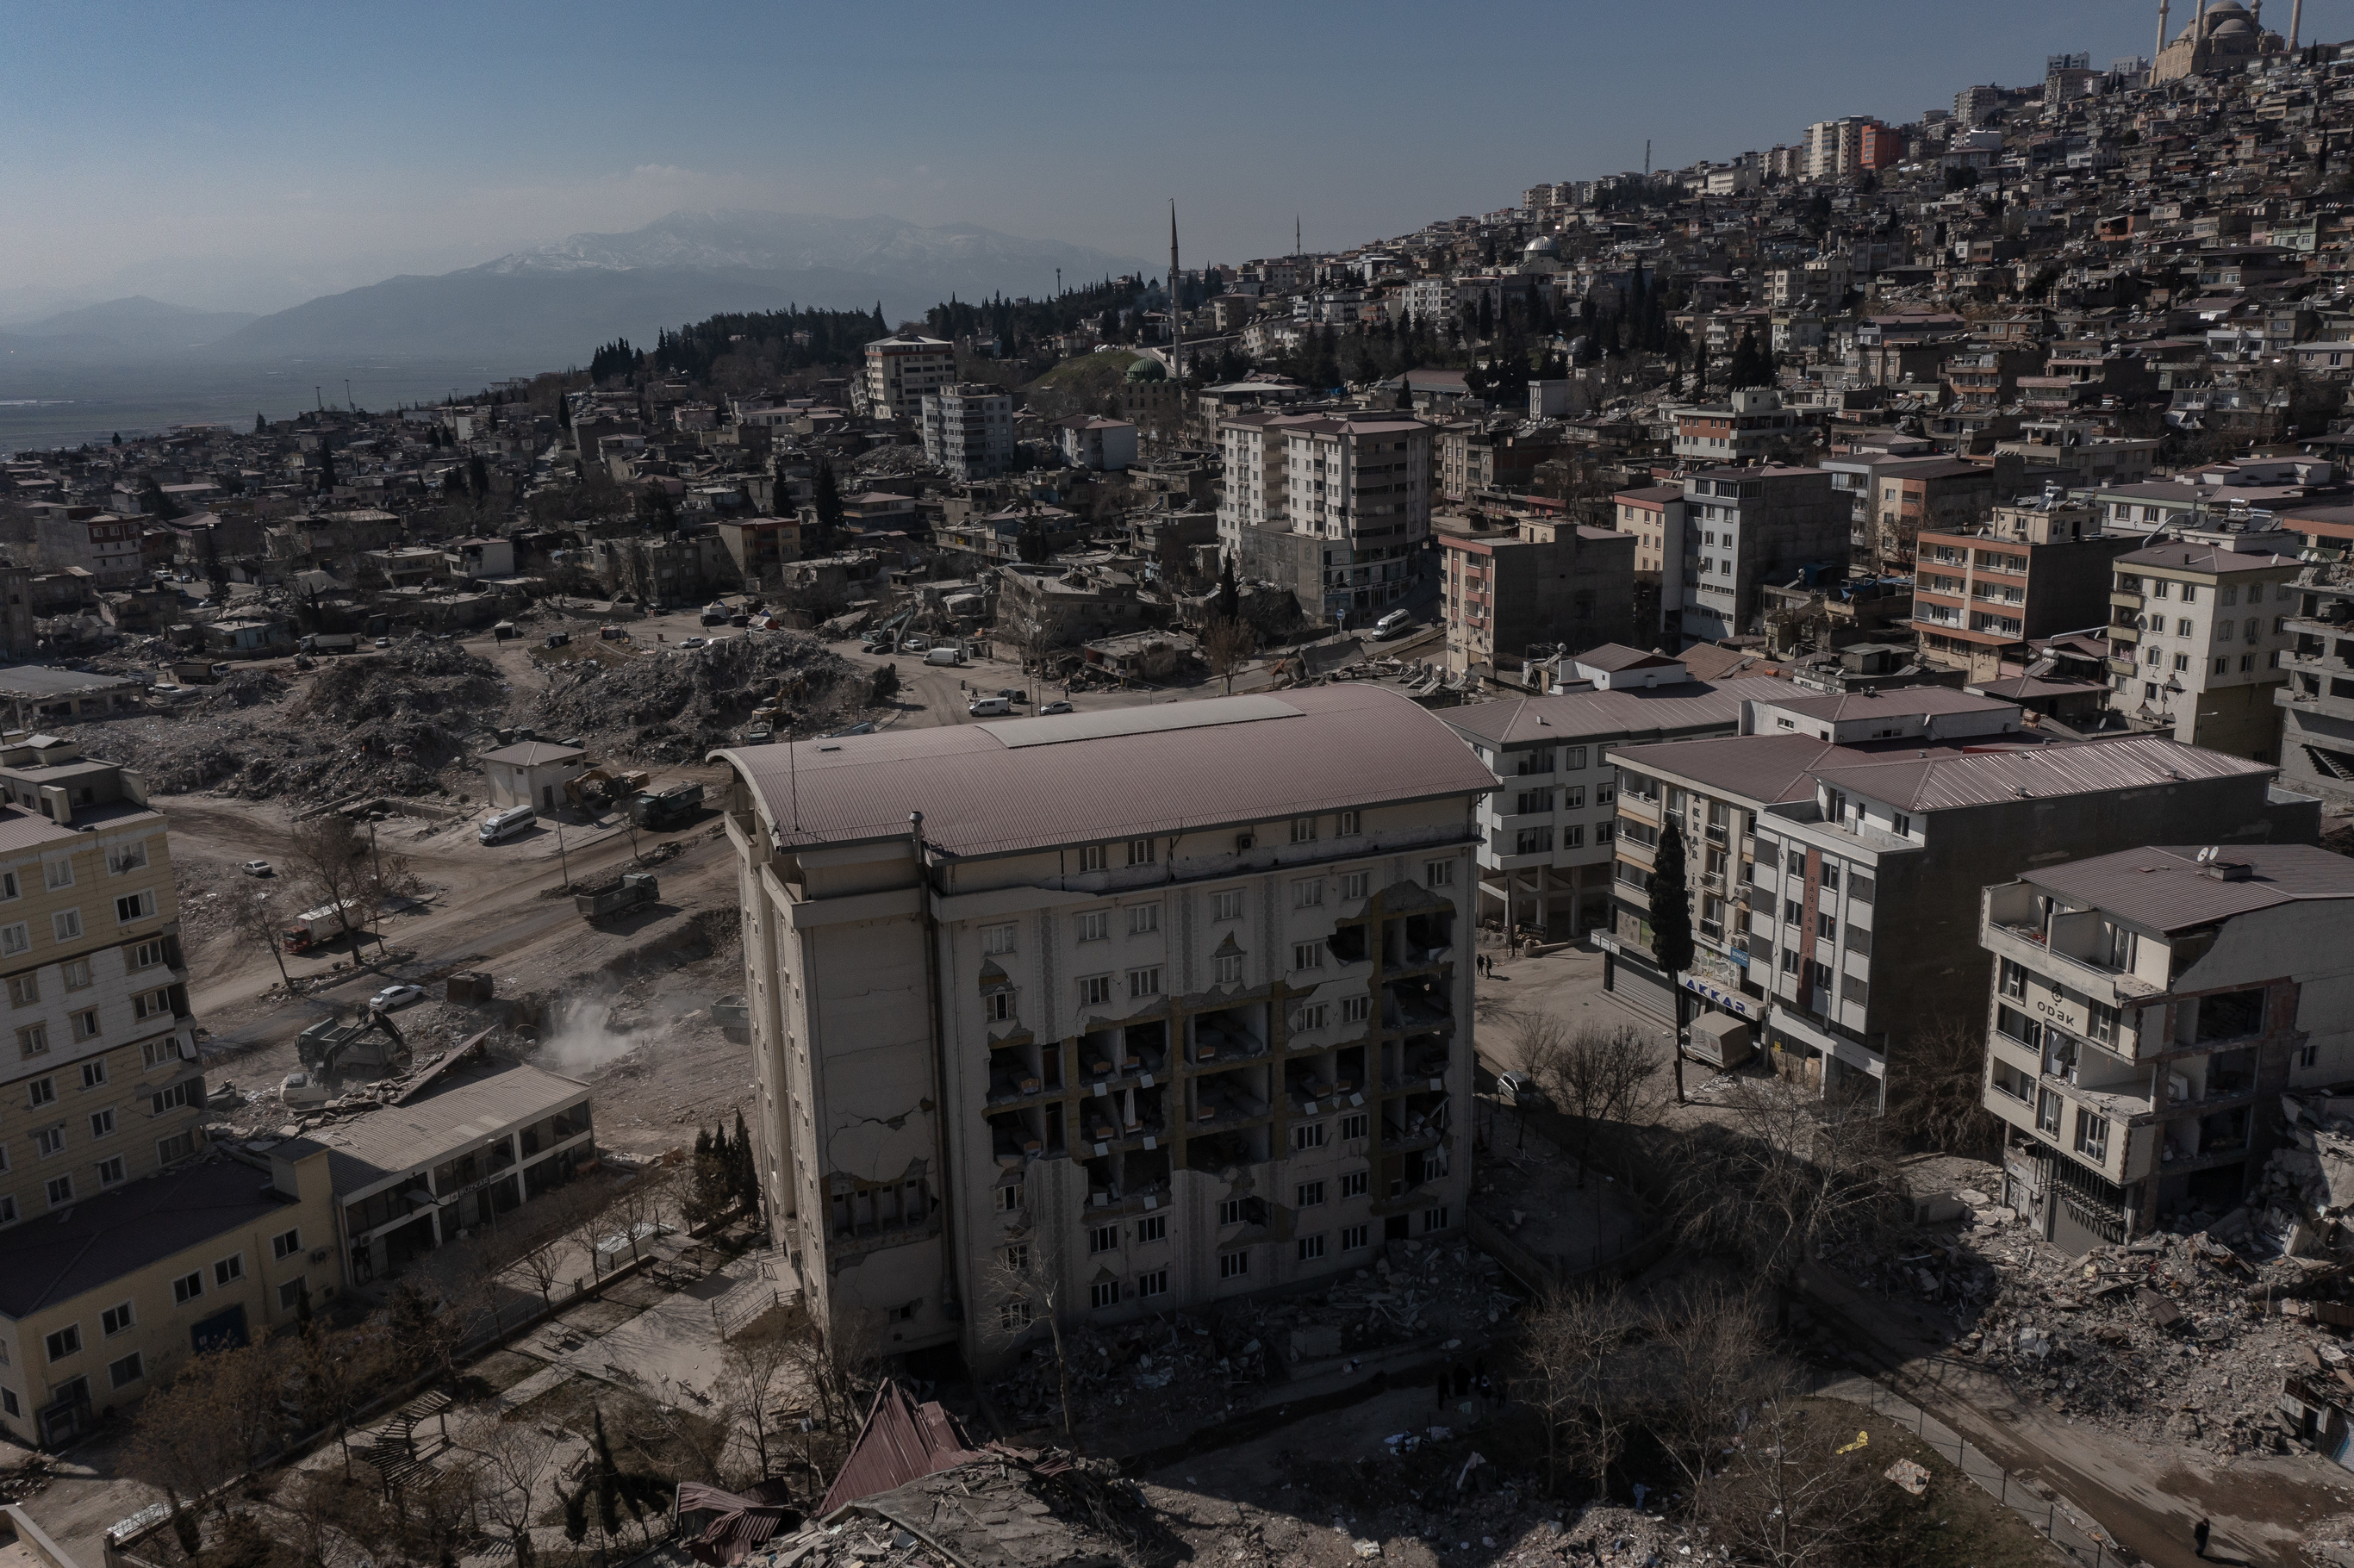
(530, 631, 866, 762)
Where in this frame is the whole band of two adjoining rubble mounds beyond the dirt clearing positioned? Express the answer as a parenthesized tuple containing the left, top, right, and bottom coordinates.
(71, 631, 866, 800)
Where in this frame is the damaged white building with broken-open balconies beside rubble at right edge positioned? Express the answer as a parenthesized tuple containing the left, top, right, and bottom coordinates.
(1980, 843, 2354, 1253)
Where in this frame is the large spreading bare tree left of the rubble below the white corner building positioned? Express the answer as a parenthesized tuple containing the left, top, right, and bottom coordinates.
(1669, 1079, 1895, 1318)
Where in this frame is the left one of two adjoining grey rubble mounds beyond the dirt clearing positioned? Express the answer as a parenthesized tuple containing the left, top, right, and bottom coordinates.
(90, 643, 504, 800)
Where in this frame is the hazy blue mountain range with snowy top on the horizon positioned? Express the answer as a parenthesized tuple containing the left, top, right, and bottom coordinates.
(0, 212, 1146, 375)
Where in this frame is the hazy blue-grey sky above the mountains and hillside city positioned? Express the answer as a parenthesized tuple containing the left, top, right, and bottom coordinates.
(0, 0, 2316, 315)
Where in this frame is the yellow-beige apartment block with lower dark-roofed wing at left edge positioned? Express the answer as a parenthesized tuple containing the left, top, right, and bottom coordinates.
(0, 732, 341, 1443)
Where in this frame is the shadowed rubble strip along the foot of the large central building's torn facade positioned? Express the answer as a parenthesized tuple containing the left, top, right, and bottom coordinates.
(991, 1241, 1518, 1427)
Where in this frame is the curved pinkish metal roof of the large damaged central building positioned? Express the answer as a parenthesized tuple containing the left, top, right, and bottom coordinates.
(713, 685, 1495, 855)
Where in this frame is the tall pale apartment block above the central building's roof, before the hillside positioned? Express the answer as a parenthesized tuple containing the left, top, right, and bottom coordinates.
(1219, 414, 1431, 624)
